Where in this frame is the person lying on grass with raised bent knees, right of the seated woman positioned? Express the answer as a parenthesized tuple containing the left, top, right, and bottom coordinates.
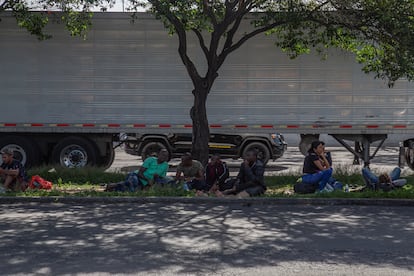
(362, 167, 407, 192)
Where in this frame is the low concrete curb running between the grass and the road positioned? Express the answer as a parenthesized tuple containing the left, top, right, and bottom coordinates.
(0, 196, 414, 207)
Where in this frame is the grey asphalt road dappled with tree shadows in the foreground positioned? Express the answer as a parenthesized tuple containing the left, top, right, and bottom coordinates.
(0, 203, 414, 276)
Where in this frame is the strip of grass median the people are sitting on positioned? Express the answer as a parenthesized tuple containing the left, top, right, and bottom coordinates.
(0, 168, 414, 199)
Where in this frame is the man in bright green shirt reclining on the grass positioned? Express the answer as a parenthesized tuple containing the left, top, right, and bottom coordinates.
(105, 149, 169, 192)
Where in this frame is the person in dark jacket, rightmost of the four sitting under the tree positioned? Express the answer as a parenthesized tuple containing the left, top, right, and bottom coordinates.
(216, 150, 266, 198)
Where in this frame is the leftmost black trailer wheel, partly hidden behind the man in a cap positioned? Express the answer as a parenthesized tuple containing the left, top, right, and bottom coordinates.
(0, 135, 42, 168)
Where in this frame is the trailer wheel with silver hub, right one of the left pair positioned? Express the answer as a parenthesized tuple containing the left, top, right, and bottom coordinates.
(51, 136, 97, 168)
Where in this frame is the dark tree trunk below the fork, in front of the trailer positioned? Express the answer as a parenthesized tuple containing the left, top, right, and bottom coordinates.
(190, 86, 210, 166)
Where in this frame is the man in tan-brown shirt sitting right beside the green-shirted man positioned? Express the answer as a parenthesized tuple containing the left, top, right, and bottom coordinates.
(175, 152, 208, 192)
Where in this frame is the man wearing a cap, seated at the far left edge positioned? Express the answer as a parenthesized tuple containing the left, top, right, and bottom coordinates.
(0, 148, 27, 191)
